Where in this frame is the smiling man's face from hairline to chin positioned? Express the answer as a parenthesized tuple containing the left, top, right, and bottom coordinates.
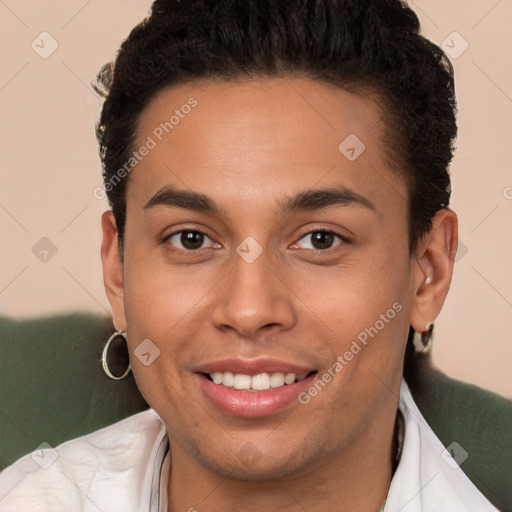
(104, 78, 450, 480)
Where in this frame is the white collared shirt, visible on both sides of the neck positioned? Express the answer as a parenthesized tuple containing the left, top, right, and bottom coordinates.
(0, 382, 498, 512)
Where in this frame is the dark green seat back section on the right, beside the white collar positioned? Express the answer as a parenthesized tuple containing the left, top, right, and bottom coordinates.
(404, 357, 512, 512)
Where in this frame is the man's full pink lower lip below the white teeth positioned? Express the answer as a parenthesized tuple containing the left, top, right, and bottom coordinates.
(196, 373, 317, 418)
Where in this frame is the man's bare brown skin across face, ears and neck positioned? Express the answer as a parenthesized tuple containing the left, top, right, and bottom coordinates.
(102, 78, 457, 512)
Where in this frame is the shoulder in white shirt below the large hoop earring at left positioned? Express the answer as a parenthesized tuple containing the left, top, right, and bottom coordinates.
(0, 409, 165, 512)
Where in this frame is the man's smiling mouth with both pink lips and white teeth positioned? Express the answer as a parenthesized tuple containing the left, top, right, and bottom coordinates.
(194, 359, 318, 418)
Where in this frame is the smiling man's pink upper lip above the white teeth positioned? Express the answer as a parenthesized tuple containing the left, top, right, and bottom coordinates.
(194, 358, 314, 376)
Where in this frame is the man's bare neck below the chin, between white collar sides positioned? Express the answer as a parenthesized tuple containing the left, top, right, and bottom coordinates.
(168, 404, 397, 512)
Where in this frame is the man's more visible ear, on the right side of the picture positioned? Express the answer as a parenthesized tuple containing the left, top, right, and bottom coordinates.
(411, 208, 458, 332)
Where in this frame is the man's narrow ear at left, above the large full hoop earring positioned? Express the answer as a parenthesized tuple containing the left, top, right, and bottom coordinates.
(101, 210, 126, 331)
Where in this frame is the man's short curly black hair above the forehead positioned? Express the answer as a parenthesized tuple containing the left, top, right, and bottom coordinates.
(94, 0, 457, 259)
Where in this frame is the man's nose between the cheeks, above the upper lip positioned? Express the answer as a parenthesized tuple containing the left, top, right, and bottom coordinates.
(213, 247, 296, 339)
